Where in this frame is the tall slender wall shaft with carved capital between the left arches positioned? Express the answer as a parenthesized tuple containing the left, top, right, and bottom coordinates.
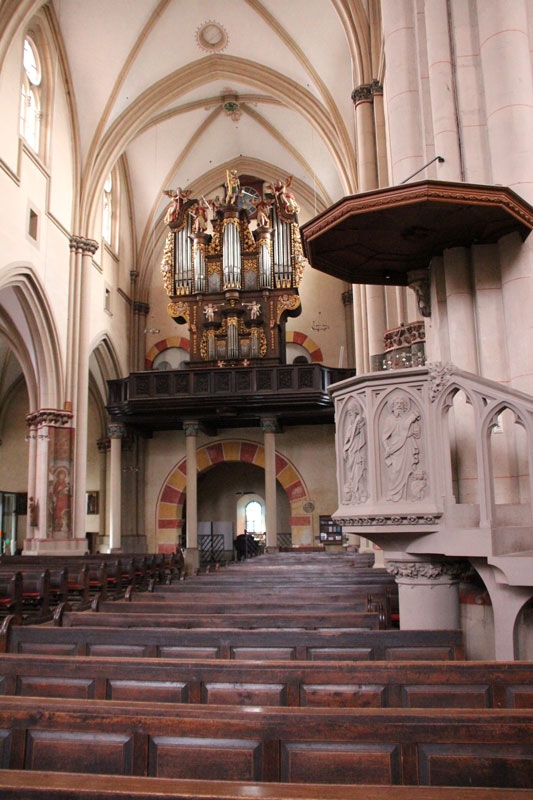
(73, 237, 98, 539)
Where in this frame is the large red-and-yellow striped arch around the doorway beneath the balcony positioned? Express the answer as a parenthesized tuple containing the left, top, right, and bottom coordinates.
(156, 439, 312, 553)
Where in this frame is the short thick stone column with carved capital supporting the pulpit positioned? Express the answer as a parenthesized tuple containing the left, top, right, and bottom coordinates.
(385, 559, 467, 630)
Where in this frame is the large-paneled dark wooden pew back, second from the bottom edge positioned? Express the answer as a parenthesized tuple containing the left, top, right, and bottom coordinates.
(0, 697, 533, 796)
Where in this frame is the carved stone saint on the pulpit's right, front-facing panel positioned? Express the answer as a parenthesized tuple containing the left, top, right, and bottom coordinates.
(382, 395, 421, 502)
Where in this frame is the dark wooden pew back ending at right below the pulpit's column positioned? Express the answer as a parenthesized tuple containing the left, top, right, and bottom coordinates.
(0, 615, 464, 661)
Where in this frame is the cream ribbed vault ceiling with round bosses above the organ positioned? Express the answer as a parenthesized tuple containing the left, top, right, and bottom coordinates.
(52, 0, 366, 247)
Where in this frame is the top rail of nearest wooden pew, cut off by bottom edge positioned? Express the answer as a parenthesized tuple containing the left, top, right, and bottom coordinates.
(0, 770, 531, 800)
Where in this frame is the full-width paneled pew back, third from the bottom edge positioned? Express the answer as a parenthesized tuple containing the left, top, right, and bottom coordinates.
(0, 654, 533, 709)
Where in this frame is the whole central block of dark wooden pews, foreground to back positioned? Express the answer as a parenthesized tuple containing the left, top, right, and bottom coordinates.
(0, 552, 533, 800)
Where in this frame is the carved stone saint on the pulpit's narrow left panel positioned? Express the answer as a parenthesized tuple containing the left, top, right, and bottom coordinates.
(342, 403, 368, 503)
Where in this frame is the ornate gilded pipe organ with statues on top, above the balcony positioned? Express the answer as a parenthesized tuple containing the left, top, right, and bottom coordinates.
(161, 170, 306, 369)
